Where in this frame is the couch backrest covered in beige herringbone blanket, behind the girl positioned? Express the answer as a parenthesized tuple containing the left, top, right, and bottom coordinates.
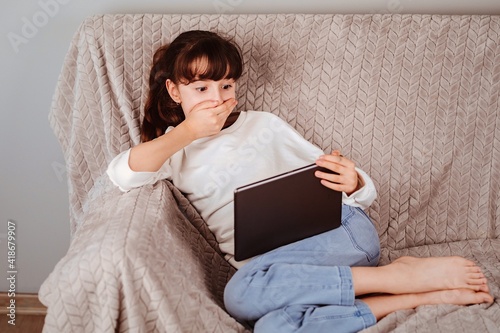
(50, 14, 500, 249)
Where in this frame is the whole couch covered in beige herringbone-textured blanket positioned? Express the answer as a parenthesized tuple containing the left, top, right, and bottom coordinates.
(39, 14, 500, 333)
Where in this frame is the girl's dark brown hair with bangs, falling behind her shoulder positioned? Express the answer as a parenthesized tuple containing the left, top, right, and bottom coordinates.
(141, 30, 243, 142)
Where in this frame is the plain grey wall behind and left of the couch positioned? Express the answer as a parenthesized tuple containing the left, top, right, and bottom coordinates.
(0, 0, 500, 292)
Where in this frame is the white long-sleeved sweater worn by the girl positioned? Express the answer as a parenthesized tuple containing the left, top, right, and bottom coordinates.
(107, 111, 377, 268)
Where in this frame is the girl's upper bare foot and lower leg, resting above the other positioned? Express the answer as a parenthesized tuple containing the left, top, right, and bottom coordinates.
(351, 257, 489, 295)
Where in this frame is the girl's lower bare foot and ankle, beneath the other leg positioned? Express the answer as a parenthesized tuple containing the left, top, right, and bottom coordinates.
(361, 289, 493, 320)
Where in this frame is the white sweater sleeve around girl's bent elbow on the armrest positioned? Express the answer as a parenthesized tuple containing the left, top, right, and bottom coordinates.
(106, 149, 172, 192)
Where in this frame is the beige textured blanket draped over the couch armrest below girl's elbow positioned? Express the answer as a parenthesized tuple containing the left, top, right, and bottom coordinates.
(40, 175, 244, 332)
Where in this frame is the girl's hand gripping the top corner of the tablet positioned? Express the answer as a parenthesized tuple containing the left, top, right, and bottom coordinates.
(315, 150, 363, 195)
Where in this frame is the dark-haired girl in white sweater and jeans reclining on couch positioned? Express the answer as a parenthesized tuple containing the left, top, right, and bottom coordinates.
(107, 31, 493, 332)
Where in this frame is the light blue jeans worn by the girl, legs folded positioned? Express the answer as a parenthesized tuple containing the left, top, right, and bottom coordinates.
(224, 205, 380, 333)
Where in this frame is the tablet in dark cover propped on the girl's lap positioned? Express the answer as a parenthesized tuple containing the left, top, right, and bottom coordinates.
(234, 164, 342, 261)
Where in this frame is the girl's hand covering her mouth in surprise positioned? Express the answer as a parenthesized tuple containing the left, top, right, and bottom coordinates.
(183, 98, 238, 140)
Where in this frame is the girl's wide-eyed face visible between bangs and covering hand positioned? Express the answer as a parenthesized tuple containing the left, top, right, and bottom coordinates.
(166, 79, 236, 117)
